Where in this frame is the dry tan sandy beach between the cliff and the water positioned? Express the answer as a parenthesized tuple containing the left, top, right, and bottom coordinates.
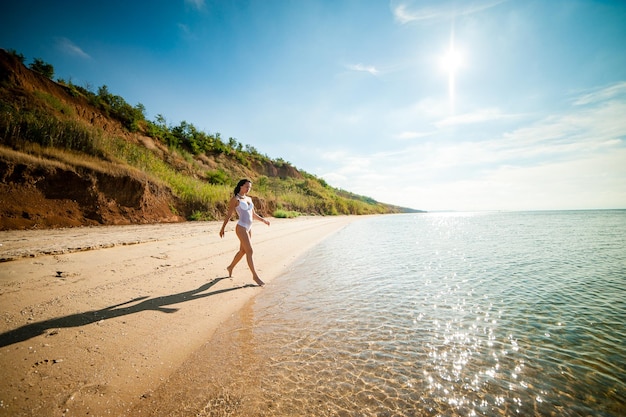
(0, 217, 356, 416)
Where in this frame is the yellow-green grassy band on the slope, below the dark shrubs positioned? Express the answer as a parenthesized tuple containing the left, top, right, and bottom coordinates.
(0, 105, 398, 219)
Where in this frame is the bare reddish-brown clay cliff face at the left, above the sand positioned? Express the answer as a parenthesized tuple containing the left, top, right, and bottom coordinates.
(0, 150, 184, 230)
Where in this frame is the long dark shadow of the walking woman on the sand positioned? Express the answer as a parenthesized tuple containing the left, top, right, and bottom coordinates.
(0, 277, 256, 347)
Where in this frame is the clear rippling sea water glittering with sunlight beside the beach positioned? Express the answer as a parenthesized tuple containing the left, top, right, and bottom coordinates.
(205, 210, 626, 416)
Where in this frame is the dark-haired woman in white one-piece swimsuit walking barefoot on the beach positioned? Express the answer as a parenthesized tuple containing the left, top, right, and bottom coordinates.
(220, 179, 270, 287)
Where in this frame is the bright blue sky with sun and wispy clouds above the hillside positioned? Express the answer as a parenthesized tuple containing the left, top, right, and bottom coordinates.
(0, 0, 626, 210)
